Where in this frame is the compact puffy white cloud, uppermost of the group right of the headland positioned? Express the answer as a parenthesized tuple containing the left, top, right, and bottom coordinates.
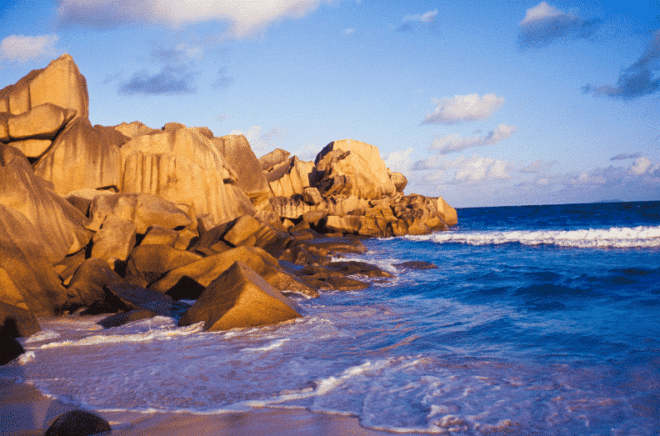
(422, 94, 504, 124)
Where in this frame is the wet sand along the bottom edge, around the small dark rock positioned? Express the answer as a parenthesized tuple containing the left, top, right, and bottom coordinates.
(0, 377, 391, 436)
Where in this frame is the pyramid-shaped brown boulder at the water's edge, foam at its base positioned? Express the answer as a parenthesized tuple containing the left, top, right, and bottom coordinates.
(179, 261, 302, 331)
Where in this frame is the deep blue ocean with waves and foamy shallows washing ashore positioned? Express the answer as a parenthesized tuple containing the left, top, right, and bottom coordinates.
(5, 202, 660, 435)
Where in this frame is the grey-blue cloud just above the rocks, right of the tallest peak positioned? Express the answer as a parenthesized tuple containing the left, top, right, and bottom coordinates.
(119, 66, 195, 95)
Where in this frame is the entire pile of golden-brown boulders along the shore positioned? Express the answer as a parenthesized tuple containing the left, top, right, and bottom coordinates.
(0, 55, 457, 350)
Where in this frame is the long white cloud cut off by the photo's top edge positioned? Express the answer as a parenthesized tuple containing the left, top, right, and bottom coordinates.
(58, 0, 332, 38)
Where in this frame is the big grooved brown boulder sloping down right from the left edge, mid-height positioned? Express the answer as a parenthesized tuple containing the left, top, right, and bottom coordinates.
(0, 144, 91, 264)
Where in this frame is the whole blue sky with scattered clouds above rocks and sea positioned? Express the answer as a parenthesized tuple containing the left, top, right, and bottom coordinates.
(0, 0, 660, 207)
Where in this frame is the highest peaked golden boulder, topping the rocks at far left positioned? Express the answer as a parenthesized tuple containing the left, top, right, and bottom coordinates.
(0, 54, 89, 118)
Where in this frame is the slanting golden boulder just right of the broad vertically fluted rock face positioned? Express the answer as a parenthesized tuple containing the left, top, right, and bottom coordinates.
(212, 135, 272, 205)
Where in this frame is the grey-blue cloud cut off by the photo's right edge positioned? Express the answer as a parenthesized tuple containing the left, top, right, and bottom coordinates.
(582, 30, 660, 100)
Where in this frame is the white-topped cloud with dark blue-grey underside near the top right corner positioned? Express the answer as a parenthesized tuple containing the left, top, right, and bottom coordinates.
(518, 1, 598, 48)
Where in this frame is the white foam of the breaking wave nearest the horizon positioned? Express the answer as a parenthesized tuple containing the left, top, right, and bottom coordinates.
(404, 226, 660, 248)
